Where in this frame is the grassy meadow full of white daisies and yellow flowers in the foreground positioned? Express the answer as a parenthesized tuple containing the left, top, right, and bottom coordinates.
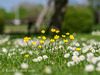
(0, 29, 100, 75)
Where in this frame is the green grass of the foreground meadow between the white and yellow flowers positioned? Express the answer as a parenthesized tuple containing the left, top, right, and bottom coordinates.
(0, 34, 100, 75)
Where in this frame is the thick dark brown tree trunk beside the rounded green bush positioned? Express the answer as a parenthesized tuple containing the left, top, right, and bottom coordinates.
(49, 0, 68, 31)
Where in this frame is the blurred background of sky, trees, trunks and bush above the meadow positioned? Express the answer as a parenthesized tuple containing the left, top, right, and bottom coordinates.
(0, 0, 100, 34)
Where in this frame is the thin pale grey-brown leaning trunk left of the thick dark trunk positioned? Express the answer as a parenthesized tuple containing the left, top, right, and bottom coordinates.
(35, 0, 52, 32)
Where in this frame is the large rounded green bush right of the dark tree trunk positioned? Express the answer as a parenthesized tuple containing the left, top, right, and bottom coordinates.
(62, 7, 94, 32)
